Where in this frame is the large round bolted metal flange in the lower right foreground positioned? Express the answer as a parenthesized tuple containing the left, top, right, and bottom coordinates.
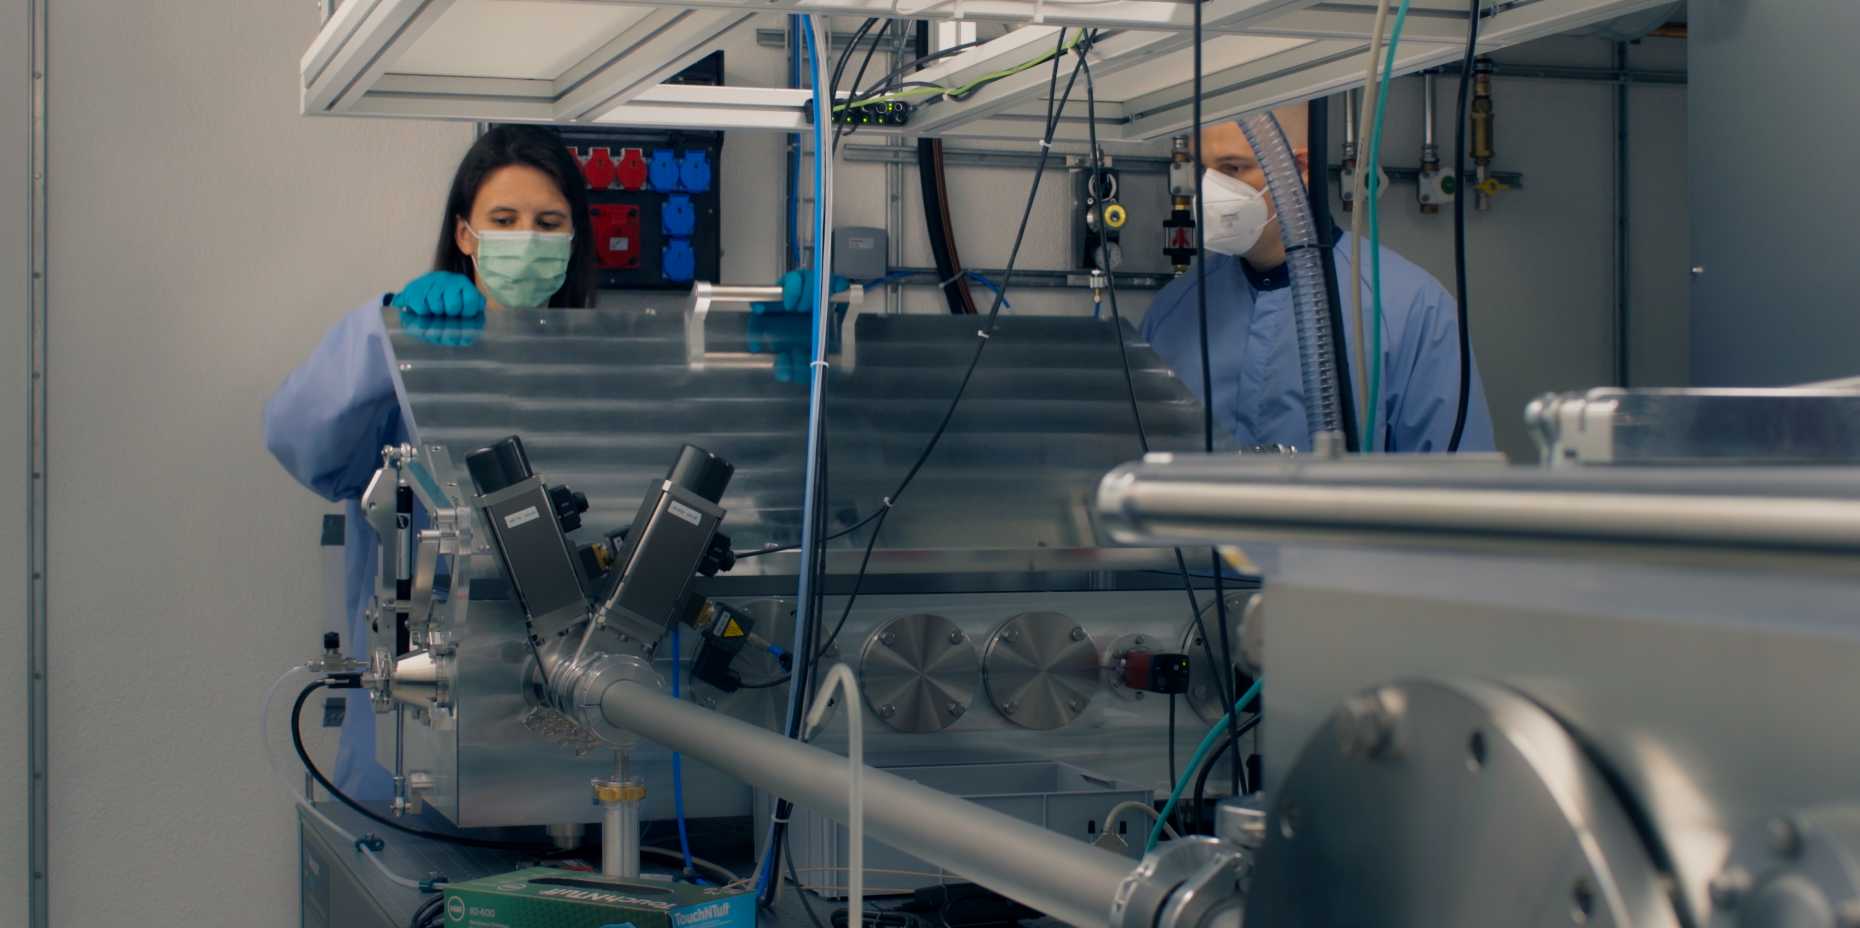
(1244, 681, 1678, 928)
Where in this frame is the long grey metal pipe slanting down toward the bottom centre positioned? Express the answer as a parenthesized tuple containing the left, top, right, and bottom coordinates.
(601, 683, 1131, 928)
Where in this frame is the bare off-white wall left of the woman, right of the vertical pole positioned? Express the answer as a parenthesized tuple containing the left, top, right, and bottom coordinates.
(41, 0, 469, 928)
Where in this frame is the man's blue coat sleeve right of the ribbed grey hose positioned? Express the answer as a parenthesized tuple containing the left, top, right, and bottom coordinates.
(1384, 275, 1497, 452)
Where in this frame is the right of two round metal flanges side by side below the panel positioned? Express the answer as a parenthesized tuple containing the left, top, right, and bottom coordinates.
(982, 612, 1103, 731)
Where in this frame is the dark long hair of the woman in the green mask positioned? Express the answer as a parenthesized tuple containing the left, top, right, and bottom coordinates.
(433, 126, 599, 309)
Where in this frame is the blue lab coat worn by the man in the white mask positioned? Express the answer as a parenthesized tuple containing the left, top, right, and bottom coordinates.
(1142, 240, 1494, 452)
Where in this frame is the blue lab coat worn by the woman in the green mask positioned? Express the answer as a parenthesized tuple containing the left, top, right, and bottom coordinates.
(264, 296, 407, 800)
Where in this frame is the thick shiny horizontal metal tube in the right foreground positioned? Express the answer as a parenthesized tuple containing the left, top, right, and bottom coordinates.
(1097, 456, 1860, 558)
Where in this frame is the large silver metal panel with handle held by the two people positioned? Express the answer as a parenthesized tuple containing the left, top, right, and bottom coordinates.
(385, 309, 1202, 569)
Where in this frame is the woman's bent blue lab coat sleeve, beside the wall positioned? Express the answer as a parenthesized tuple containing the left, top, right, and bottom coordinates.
(264, 301, 400, 500)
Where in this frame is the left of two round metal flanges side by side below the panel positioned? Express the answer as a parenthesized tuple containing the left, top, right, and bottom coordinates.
(859, 614, 982, 735)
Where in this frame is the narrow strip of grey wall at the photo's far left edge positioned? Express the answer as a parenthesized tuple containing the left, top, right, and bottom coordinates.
(0, 4, 32, 924)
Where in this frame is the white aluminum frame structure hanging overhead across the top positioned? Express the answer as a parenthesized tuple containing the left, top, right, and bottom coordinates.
(301, 0, 1663, 145)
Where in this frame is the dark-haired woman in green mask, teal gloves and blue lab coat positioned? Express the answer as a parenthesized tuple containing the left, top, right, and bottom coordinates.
(264, 126, 595, 800)
